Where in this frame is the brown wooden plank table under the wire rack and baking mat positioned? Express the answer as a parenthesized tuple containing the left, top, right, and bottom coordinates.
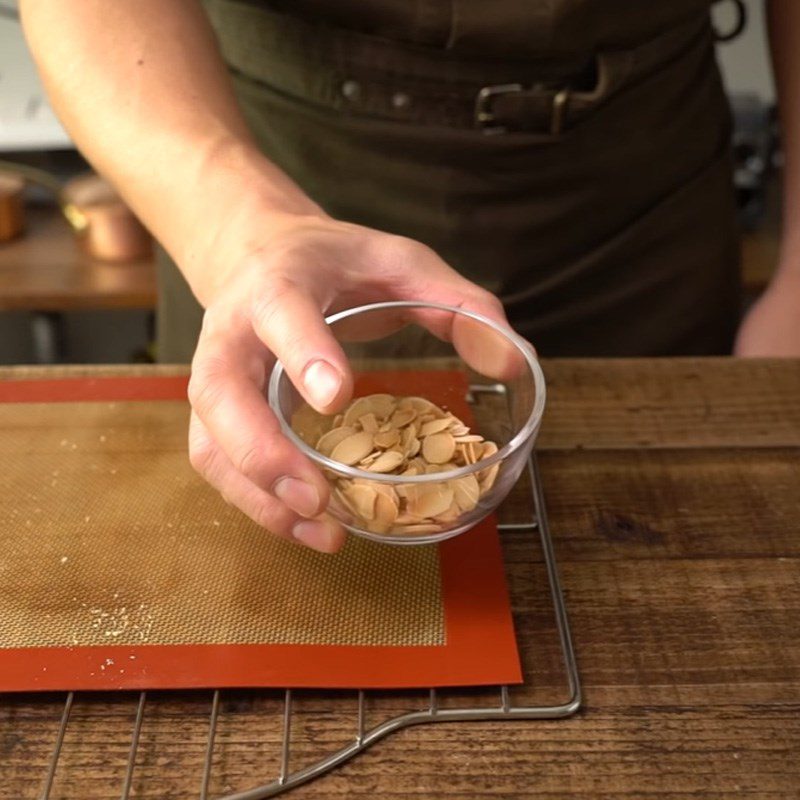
(0, 359, 800, 800)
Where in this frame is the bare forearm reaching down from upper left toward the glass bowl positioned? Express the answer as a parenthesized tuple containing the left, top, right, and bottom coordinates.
(20, 0, 317, 302)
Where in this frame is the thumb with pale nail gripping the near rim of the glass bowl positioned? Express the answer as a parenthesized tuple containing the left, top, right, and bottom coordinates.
(251, 278, 353, 414)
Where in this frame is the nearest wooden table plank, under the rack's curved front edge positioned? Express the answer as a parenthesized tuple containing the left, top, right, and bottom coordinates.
(0, 702, 800, 800)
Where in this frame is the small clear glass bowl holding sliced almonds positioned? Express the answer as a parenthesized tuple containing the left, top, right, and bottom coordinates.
(269, 301, 545, 545)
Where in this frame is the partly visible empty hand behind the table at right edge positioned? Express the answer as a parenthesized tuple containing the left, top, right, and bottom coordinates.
(734, 270, 800, 357)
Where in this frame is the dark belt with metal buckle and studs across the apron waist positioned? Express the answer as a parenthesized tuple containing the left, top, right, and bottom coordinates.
(206, 0, 712, 137)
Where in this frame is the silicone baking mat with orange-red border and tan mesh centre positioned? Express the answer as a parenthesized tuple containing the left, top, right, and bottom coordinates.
(0, 371, 521, 691)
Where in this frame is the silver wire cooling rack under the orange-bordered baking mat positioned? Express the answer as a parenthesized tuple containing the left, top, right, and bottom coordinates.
(9, 385, 581, 800)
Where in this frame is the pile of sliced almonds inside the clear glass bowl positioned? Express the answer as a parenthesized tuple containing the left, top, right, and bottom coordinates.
(316, 394, 500, 535)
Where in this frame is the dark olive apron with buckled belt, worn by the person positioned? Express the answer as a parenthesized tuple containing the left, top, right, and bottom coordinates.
(159, 0, 739, 360)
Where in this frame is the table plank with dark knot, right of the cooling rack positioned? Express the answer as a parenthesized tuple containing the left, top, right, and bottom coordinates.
(532, 448, 800, 561)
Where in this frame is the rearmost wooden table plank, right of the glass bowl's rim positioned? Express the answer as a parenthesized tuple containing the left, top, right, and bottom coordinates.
(538, 358, 800, 449)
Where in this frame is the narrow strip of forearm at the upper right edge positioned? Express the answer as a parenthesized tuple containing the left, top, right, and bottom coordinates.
(767, 0, 800, 279)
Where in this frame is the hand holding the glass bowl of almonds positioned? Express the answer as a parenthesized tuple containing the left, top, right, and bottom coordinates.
(189, 209, 505, 552)
